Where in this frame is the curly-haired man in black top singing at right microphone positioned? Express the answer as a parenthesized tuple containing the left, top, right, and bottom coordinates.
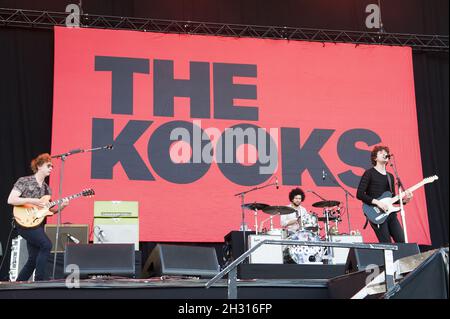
(356, 145, 412, 243)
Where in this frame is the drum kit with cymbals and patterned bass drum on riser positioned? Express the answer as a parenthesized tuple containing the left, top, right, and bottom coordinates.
(242, 200, 341, 264)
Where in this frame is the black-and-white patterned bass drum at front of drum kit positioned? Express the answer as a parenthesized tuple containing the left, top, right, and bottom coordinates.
(286, 231, 325, 264)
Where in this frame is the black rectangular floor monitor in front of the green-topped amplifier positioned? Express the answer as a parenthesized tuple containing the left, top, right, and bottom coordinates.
(64, 244, 135, 278)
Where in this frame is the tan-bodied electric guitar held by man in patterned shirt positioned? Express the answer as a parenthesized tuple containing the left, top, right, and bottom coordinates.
(13, 188, 95, 228)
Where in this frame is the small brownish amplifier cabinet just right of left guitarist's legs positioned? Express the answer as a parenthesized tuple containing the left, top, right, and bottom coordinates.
(45, 224, 89, 253)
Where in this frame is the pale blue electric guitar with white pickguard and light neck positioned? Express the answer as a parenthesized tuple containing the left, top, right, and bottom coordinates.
(363, 175, 438, 225)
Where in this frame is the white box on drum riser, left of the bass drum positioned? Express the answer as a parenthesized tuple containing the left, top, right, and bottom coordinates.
(248, 235, 283, 264)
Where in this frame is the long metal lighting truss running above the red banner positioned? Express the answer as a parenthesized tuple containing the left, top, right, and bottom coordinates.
(0, 8, 449, 52)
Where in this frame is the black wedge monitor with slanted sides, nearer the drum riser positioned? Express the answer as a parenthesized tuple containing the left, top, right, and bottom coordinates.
(142, 244, 220, 278)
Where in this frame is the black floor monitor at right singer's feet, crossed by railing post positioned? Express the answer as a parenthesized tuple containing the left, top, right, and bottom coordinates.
(345, 243, 420, 273)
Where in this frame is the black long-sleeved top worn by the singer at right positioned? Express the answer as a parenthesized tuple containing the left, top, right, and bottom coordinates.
(356, 167, 395, 205)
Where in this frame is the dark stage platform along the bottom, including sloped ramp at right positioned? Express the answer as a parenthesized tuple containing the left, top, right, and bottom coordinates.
(0, 248, 448, 300)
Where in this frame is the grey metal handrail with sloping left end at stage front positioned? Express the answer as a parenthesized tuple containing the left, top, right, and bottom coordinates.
(205, 239, 398, 299)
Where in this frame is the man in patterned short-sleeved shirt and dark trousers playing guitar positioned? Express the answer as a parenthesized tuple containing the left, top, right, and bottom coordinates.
(8, 153, 68, 281)
